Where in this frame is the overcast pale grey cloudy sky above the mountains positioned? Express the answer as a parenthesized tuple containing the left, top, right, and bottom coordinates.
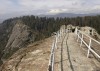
(0, 0, 100, 19)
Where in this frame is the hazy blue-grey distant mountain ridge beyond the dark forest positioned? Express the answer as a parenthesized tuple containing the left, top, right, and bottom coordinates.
(0, 13, 100, 23)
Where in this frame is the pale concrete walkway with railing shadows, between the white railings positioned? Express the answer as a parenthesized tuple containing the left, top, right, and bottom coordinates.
(54, 33, 100, 71)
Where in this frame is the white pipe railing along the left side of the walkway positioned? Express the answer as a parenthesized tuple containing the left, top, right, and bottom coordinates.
(47, 25, 66, 71)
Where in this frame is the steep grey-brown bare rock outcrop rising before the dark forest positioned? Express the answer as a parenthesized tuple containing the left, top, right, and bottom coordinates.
(2, 21, 35, 60)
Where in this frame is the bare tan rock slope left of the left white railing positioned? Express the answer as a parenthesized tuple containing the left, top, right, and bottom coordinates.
(0, 37, 53, 71)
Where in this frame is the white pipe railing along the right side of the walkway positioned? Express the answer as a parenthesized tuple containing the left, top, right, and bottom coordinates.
(75, 28, 100, 58)
